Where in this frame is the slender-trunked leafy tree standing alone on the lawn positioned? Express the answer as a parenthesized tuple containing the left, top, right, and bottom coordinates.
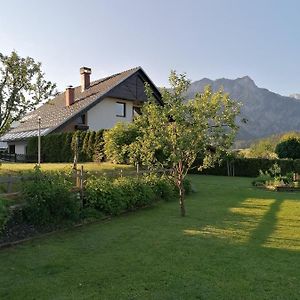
(130, 71, 239, 216)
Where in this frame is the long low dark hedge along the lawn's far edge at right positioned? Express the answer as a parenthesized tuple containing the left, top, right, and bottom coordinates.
(190, 158, 300, 177)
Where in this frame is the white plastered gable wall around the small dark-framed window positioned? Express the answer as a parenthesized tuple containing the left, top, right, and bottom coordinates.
(87, 98, 133, 131)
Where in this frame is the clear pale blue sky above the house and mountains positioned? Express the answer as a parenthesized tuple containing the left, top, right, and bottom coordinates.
(0, 0, 300, 95)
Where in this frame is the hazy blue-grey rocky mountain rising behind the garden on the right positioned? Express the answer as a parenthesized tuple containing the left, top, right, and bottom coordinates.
(187, 76, 300, 141)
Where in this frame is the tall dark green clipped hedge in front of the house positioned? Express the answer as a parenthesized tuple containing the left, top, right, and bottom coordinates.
(27, 130, 104, 162)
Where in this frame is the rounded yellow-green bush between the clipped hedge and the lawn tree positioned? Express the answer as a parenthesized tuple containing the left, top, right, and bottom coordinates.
(104, 123, 138, 164)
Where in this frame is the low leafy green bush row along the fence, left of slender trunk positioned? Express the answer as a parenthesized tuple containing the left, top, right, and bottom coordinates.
(85, 176, 174, 215)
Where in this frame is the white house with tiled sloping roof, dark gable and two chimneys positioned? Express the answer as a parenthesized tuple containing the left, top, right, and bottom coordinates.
(0, 67, 161, 154)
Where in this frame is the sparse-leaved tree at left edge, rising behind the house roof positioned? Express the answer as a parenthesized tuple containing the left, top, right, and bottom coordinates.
(0, 51, 55, 134)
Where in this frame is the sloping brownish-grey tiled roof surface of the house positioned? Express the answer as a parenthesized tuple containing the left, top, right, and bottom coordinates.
(0, 67, 159, 142)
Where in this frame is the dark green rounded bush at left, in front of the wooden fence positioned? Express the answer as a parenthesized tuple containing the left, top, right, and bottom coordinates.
(22, 170, 80, 225)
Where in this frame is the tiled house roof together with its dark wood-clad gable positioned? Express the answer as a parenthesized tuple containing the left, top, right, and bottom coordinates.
(0, 67, 161, 141)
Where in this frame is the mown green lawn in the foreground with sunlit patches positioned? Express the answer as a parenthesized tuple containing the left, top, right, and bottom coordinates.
(0, 176, 300, 299)
